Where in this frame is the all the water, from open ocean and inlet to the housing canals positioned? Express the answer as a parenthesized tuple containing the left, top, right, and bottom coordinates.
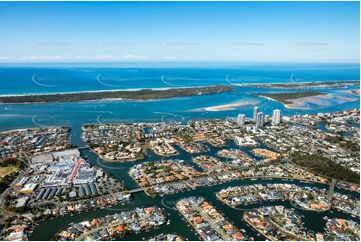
(0, 64, 360, 240)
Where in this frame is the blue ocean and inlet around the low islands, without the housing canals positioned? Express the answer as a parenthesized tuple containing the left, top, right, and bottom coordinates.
(0, 63, 360, 130)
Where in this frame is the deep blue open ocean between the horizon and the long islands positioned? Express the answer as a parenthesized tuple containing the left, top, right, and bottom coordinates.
(0, 63, 360, 95)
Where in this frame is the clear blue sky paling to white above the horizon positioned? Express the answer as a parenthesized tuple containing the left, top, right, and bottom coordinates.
(0, 2, 360, 63)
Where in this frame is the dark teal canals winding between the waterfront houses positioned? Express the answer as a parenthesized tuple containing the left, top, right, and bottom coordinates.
(30, 133, 359, 240)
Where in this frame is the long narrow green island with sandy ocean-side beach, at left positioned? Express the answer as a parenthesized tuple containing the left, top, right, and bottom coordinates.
(0, 86, 234, 103)
